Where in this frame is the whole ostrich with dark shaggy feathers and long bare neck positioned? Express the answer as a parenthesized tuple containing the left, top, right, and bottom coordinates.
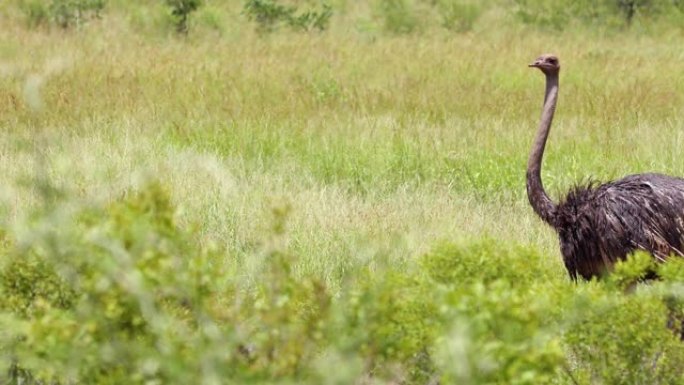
(527, 55, 684, 280)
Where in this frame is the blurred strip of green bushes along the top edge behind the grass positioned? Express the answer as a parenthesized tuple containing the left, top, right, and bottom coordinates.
(8, 0, 684, 34)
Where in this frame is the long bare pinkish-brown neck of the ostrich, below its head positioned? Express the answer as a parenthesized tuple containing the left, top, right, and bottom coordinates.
(527, 73, 558, 226)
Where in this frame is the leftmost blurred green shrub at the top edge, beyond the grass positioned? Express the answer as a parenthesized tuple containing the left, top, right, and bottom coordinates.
(21, 0, 107, 29)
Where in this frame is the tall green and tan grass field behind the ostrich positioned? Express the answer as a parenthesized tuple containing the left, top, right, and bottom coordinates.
(2, 26, 684, 270)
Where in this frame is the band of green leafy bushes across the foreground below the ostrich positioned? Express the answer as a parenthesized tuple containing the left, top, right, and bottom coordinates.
(0, 183, 684, 384)
